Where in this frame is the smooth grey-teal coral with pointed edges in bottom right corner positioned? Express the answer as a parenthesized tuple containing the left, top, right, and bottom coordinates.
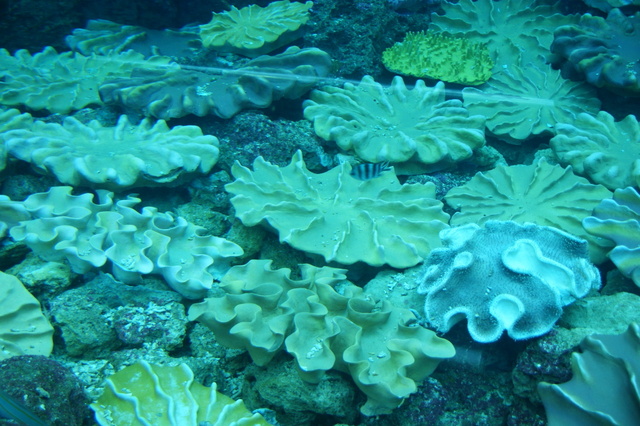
(538, 323, 640, 426)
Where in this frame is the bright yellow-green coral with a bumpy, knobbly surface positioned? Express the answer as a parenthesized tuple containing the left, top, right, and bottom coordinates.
(382, 31, 493, 86)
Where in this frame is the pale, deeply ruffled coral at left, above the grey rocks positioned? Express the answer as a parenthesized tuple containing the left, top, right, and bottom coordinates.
(9, 186, 242, 299)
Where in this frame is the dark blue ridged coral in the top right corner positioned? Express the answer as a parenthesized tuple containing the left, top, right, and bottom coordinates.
(551, 9, 640, 95)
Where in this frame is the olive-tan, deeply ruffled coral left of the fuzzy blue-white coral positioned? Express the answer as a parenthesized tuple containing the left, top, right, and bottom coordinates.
(189, 260, 455, 415)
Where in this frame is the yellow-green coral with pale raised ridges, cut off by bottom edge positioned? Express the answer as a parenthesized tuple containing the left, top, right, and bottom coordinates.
(91, 361, 270, 426)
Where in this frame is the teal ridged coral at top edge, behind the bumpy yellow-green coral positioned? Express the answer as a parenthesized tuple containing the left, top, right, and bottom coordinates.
(429, 0, 577, 69)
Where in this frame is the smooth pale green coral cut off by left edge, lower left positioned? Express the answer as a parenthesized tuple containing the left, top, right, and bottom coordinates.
(0, 272, 53, 360)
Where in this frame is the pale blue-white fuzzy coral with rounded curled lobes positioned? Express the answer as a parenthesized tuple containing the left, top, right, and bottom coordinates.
(418, 221, 600, 343)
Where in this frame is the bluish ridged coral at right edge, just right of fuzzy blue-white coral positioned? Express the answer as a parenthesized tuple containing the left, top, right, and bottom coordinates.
(582, 188, 640, 287)
